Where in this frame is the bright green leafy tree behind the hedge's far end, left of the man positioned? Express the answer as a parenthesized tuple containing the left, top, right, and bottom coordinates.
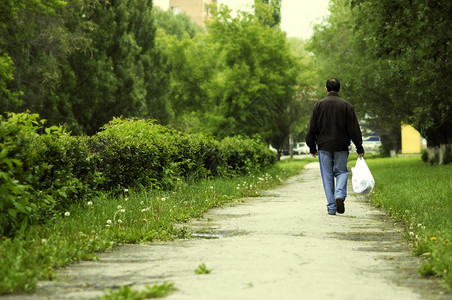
(206, 4, 299, 142)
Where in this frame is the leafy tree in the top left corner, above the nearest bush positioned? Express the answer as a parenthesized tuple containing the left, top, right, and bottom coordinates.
(0, 0, 73, 122)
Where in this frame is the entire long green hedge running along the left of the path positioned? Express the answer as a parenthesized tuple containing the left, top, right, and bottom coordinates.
(0, 113, 277, 235)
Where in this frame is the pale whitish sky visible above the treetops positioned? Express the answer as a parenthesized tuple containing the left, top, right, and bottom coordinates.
(154, 0, 329, 39)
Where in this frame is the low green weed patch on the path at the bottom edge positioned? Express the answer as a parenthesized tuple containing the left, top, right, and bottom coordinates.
(102, 282, 177, 300)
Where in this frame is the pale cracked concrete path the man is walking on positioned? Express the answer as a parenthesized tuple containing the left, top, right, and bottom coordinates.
(5, 163, 451, 300)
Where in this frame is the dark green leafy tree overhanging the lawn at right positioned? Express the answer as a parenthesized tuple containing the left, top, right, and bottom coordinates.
(352, 0, 452, 162)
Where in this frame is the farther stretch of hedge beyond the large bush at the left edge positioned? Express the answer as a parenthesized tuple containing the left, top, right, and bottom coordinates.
(91, 119, 275, 190)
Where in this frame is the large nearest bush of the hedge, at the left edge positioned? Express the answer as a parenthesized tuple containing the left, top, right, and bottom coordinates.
(0, 113, 101, 235)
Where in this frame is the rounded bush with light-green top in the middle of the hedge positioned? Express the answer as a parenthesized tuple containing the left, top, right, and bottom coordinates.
(90, 118, 178, 191)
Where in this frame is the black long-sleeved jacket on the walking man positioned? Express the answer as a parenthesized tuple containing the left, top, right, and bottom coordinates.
(306, 92, 364, 153)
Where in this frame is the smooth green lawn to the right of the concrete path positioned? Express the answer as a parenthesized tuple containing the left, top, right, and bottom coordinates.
(350, 156, 452, 288)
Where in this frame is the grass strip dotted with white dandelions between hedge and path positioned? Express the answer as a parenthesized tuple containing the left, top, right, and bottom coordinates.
(0, 159, 310, 294)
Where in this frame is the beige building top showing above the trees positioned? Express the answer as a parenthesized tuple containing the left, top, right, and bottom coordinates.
(169, 0, 217, 27)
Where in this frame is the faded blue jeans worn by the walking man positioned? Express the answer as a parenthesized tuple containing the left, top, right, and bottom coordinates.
(319, 150, 348, 213)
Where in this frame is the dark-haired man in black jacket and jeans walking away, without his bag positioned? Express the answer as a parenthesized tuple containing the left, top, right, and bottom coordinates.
(306, 78, 364, 215)
